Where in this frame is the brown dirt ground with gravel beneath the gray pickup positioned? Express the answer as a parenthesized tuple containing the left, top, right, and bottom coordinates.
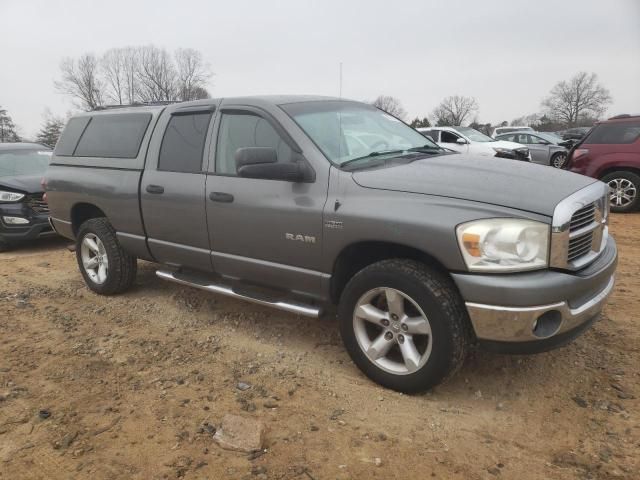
(0, 215, 640, 480)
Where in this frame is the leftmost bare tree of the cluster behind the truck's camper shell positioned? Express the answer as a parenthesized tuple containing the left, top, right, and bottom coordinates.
(54, 53, 103, 110)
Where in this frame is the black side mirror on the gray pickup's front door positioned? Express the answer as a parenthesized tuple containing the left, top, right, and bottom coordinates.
(235, 147, 315, 183)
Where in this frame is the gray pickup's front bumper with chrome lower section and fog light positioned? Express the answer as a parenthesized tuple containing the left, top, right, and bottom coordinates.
(454, 237, 617, 353)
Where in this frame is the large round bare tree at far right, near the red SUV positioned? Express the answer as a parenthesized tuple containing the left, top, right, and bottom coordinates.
(542, 72, 611, 127)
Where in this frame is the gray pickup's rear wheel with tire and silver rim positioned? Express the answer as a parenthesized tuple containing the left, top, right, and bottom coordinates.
(76, 218, 137, 295)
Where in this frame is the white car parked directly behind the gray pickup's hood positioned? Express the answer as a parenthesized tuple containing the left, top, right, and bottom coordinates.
(418, 127, 531, 162)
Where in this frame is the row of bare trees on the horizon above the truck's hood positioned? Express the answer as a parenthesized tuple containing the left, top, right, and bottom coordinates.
(371, 72, 612, 134)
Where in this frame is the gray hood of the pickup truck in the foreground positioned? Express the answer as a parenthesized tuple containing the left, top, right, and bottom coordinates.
(353, 154, 597, 216)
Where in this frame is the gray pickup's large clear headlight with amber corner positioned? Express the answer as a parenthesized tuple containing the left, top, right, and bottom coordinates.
(456, 218, 550, 272)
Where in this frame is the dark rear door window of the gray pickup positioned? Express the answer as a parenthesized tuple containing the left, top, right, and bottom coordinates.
(158, 112, 211, 173)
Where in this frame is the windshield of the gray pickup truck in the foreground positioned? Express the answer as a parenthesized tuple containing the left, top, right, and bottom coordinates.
(282, 101, 440, 165)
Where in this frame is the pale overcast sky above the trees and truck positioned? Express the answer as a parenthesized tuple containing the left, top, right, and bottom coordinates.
(0, 0, 640, 136)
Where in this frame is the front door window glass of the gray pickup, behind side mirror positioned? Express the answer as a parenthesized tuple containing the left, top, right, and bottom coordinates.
(216, 113, 292, 175)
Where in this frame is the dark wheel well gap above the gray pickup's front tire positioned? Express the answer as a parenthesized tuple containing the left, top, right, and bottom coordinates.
(330, 242, 448, 303)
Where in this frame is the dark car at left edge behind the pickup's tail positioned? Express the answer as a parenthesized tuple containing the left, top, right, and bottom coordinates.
(0, 143, 54, 252)
